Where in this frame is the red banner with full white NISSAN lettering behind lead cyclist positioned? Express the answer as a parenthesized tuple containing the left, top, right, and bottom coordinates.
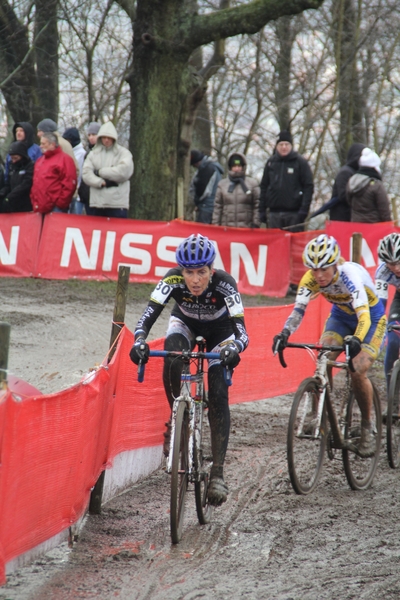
(36, 213, 290, 296)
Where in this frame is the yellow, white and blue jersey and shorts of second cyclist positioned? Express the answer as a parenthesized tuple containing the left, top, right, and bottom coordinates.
(285, 262, 386, 355)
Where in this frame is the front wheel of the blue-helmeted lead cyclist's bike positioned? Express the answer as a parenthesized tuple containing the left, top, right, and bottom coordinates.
(170, 401, 189, 544)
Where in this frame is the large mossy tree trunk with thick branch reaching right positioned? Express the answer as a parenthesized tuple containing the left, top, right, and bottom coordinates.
(128, 0, 322, 220)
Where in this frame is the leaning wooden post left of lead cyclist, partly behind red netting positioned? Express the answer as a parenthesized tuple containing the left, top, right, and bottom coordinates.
(89, 266, 130, 515)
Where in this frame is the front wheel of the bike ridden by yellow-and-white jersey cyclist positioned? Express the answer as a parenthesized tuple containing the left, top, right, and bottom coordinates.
(287, 377, 326, 494)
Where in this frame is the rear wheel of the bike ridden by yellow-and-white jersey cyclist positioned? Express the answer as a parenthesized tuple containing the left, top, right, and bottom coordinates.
(342, 382, 382, 490)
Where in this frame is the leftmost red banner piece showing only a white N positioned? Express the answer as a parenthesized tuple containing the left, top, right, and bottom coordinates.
(0, 213, 42, 277)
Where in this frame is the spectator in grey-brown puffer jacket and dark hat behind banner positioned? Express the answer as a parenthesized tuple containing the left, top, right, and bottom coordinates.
(212, 152, 260, 227)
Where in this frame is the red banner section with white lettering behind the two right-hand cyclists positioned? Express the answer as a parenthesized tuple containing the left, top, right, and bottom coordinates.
(326, 221, 400, 278)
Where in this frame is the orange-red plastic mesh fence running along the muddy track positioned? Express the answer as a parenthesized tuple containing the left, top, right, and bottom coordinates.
(0, 299, 329, 583)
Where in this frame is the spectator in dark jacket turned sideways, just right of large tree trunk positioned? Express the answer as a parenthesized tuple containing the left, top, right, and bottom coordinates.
(189, 150, 224, 223)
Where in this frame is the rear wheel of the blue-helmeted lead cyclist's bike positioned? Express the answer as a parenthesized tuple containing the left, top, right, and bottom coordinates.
(194, 408, 213, 525)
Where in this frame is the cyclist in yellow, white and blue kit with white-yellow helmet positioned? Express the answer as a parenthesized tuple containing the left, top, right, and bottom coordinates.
(272, 234, 386, 457)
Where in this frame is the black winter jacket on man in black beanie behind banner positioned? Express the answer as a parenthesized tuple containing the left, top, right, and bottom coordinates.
(260, 150, 314, 222)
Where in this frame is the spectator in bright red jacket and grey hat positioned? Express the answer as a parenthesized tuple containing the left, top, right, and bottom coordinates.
(31, 132, 77, 214)
